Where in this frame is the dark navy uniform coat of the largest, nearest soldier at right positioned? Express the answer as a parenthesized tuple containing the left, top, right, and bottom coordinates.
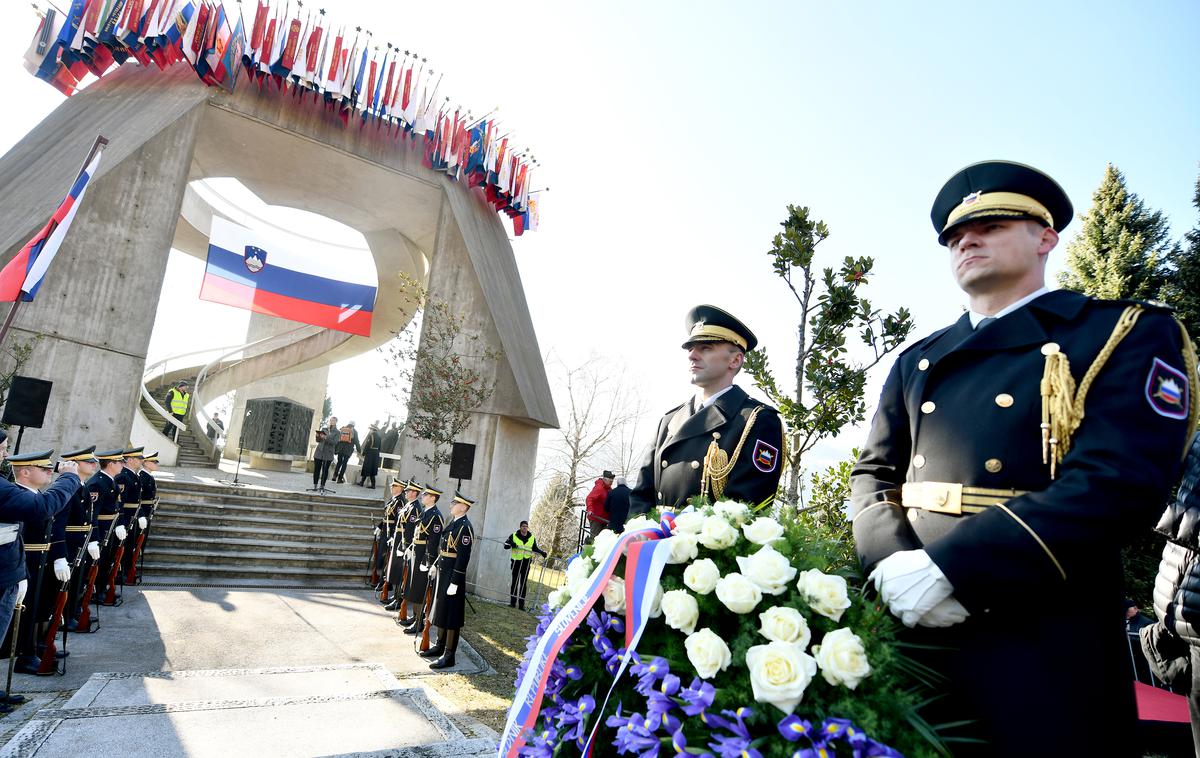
(851, 290, 1192, 754)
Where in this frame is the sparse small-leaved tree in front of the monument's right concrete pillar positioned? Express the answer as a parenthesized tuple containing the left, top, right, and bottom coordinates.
(380, 276, 503, 474)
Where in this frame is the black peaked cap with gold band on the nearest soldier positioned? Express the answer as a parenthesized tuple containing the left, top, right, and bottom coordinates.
(929, 161, 1075, 245)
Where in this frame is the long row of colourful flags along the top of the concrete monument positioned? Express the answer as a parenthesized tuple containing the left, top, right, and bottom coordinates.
(25, 0, 539, 235)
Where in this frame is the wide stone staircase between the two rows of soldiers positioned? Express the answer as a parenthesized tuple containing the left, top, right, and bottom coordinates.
(144, 480, 383, 589)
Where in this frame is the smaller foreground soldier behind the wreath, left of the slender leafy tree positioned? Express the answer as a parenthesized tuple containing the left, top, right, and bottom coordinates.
(629, 306, 784, 513)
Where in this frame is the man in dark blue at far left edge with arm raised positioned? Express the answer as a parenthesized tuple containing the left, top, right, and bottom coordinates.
(0, 450, 79, 714)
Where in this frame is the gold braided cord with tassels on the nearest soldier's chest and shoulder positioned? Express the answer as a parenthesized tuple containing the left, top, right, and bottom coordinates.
(1042, 306, 1142, 479)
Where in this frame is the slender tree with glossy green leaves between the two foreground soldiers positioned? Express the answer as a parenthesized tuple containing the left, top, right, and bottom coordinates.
(745, 205, 913, 503)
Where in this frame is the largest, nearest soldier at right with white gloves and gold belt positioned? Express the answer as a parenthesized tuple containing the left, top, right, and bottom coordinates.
(851, 161, 1198, 756)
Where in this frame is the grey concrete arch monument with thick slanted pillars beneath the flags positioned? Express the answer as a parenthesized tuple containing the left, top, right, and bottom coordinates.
(0, 66, 557, 594)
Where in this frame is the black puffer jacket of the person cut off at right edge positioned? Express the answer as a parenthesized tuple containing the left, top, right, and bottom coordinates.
(1154, 434, 1200, 644)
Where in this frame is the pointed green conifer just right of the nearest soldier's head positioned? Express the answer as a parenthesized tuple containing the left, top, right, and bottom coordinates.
(1058, 163, 1174, 300)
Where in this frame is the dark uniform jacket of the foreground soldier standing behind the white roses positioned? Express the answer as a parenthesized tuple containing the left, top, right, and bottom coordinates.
(629, 385, 784, 515)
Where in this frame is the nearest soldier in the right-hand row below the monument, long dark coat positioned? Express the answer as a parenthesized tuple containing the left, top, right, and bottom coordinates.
(420, 492, 475, 668)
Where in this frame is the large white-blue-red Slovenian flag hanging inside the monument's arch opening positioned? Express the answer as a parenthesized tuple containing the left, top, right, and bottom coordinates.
(200, 216, 376, 337)
